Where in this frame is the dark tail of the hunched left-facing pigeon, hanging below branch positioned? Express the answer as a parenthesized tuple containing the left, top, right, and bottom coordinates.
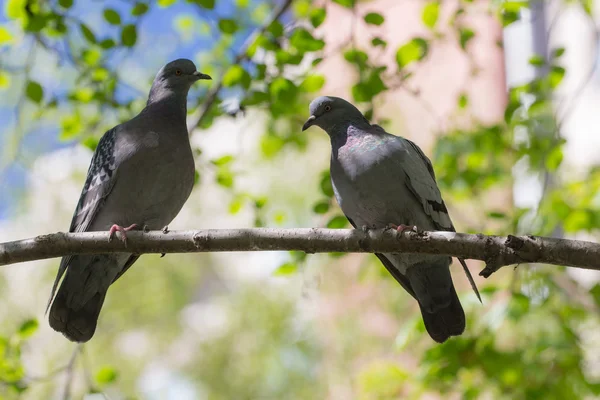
(406, 258, 466, 343)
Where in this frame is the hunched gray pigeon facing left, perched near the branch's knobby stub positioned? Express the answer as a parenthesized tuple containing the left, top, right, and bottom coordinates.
(302, 96, 479, 343)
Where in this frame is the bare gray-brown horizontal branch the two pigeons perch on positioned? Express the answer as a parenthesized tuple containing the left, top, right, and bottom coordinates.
(0, 228, 600, 278)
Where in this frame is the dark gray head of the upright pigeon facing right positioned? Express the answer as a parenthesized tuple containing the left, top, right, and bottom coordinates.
(148, 58, 212, 104)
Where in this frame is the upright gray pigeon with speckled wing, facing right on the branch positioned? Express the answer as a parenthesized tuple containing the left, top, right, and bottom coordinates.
(49, 59, 211, 342)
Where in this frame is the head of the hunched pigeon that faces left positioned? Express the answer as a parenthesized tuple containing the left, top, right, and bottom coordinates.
(302, 96, 369, 135)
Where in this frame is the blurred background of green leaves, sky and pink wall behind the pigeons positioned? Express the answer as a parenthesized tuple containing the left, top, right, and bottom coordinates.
(0, 0, 600, 400)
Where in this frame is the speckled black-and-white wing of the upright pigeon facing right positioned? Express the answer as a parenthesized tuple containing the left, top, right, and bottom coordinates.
(46, 127, 117, 311)
